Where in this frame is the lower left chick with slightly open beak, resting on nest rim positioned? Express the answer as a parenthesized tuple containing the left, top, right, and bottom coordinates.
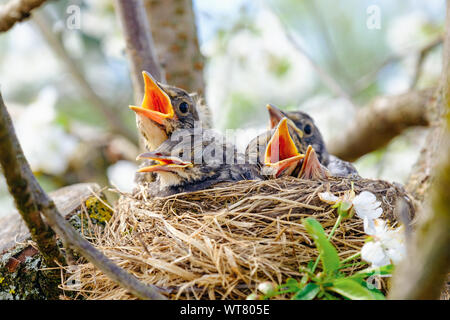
(137, 129, 262, 197)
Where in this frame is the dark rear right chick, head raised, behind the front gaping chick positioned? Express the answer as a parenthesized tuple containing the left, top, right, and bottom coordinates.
(267, 104, 360, 178)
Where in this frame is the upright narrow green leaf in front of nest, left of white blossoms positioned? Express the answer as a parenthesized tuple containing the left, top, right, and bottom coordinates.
(303, 218, 340, 277)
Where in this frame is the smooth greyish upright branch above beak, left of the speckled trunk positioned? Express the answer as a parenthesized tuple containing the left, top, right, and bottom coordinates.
(115, 0, 165, 103)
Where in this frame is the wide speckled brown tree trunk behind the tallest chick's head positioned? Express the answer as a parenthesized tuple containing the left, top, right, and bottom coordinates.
(144, 0, 205, 95)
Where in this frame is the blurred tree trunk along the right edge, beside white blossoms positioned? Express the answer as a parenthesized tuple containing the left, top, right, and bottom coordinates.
(389, 0, 450, 299)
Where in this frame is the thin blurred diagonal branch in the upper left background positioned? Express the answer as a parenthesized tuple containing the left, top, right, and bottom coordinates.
(32, 12, 137, 144)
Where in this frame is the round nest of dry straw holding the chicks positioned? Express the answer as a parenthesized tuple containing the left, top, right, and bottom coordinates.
(63, 177, 412, 299)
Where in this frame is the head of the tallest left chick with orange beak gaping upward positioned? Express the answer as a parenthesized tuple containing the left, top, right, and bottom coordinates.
(130, 71, 199, 148)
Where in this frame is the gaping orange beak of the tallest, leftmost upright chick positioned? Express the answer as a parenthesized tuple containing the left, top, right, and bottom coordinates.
(130, 71, 175, 124)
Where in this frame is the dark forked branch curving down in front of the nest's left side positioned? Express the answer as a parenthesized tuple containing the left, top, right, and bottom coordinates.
(0, 93, 166, 299)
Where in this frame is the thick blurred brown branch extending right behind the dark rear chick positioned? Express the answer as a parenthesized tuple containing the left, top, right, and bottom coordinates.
(327, 89, 434, 161)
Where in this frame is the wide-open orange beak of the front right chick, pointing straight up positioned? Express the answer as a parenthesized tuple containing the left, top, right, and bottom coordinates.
(264, 118, 304, 178)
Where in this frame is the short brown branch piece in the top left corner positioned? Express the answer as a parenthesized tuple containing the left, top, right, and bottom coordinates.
(0, 0, 46, 32)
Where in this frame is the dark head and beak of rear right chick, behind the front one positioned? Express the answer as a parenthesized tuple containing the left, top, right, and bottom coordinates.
(267, 104, 329, 165)
